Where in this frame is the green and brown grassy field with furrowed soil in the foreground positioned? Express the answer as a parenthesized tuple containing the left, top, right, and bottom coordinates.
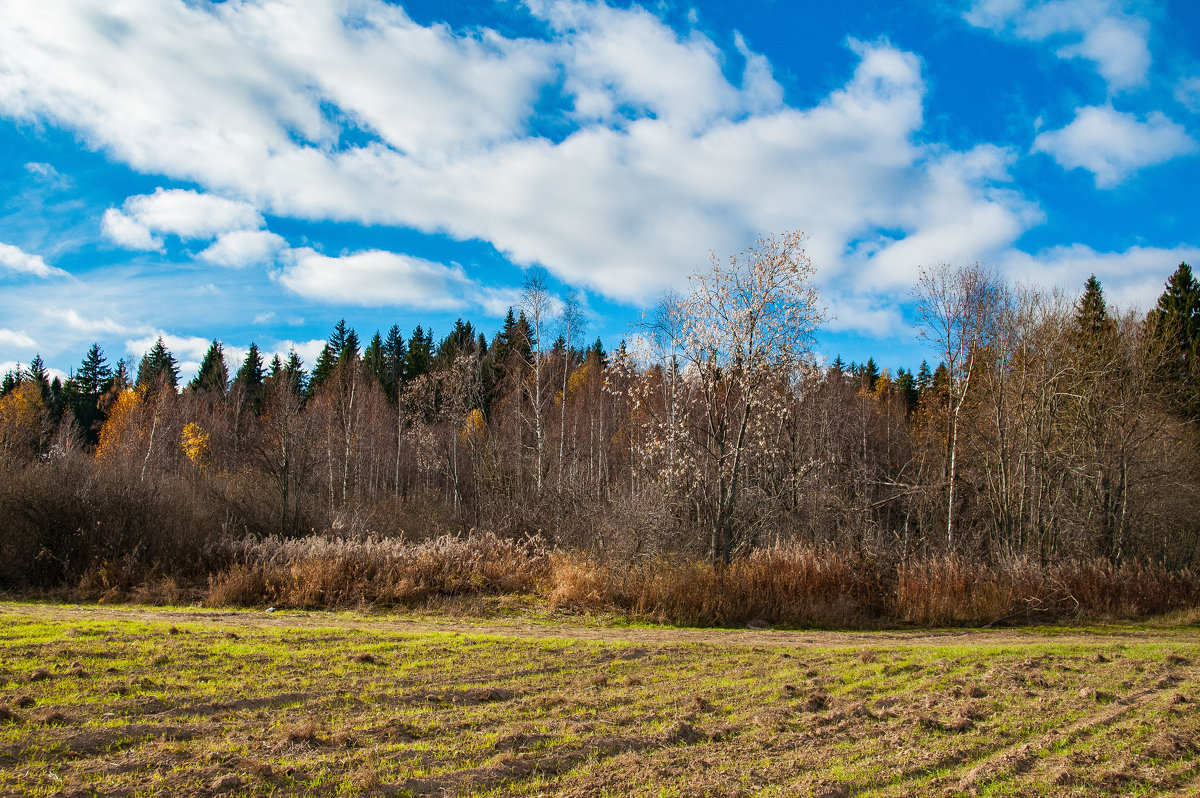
(0, 604, 1200, 796)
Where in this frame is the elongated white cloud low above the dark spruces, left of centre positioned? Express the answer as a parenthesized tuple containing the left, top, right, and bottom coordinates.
(278, 248, 484, 311)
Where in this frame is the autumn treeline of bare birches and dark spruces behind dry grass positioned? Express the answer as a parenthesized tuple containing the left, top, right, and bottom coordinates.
(0, 235, 1200, 624)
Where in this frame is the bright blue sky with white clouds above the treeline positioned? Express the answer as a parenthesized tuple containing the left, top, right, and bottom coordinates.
(0, 0, 1200, 379)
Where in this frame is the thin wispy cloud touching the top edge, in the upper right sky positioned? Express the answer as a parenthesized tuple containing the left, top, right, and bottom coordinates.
(964, 0, 1151, 89)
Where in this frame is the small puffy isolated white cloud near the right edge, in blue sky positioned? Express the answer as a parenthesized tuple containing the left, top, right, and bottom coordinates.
(1033, 106, 1196, 188)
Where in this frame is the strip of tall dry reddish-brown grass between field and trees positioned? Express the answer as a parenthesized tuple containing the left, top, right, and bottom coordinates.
(196, 534, 1200, 628)
